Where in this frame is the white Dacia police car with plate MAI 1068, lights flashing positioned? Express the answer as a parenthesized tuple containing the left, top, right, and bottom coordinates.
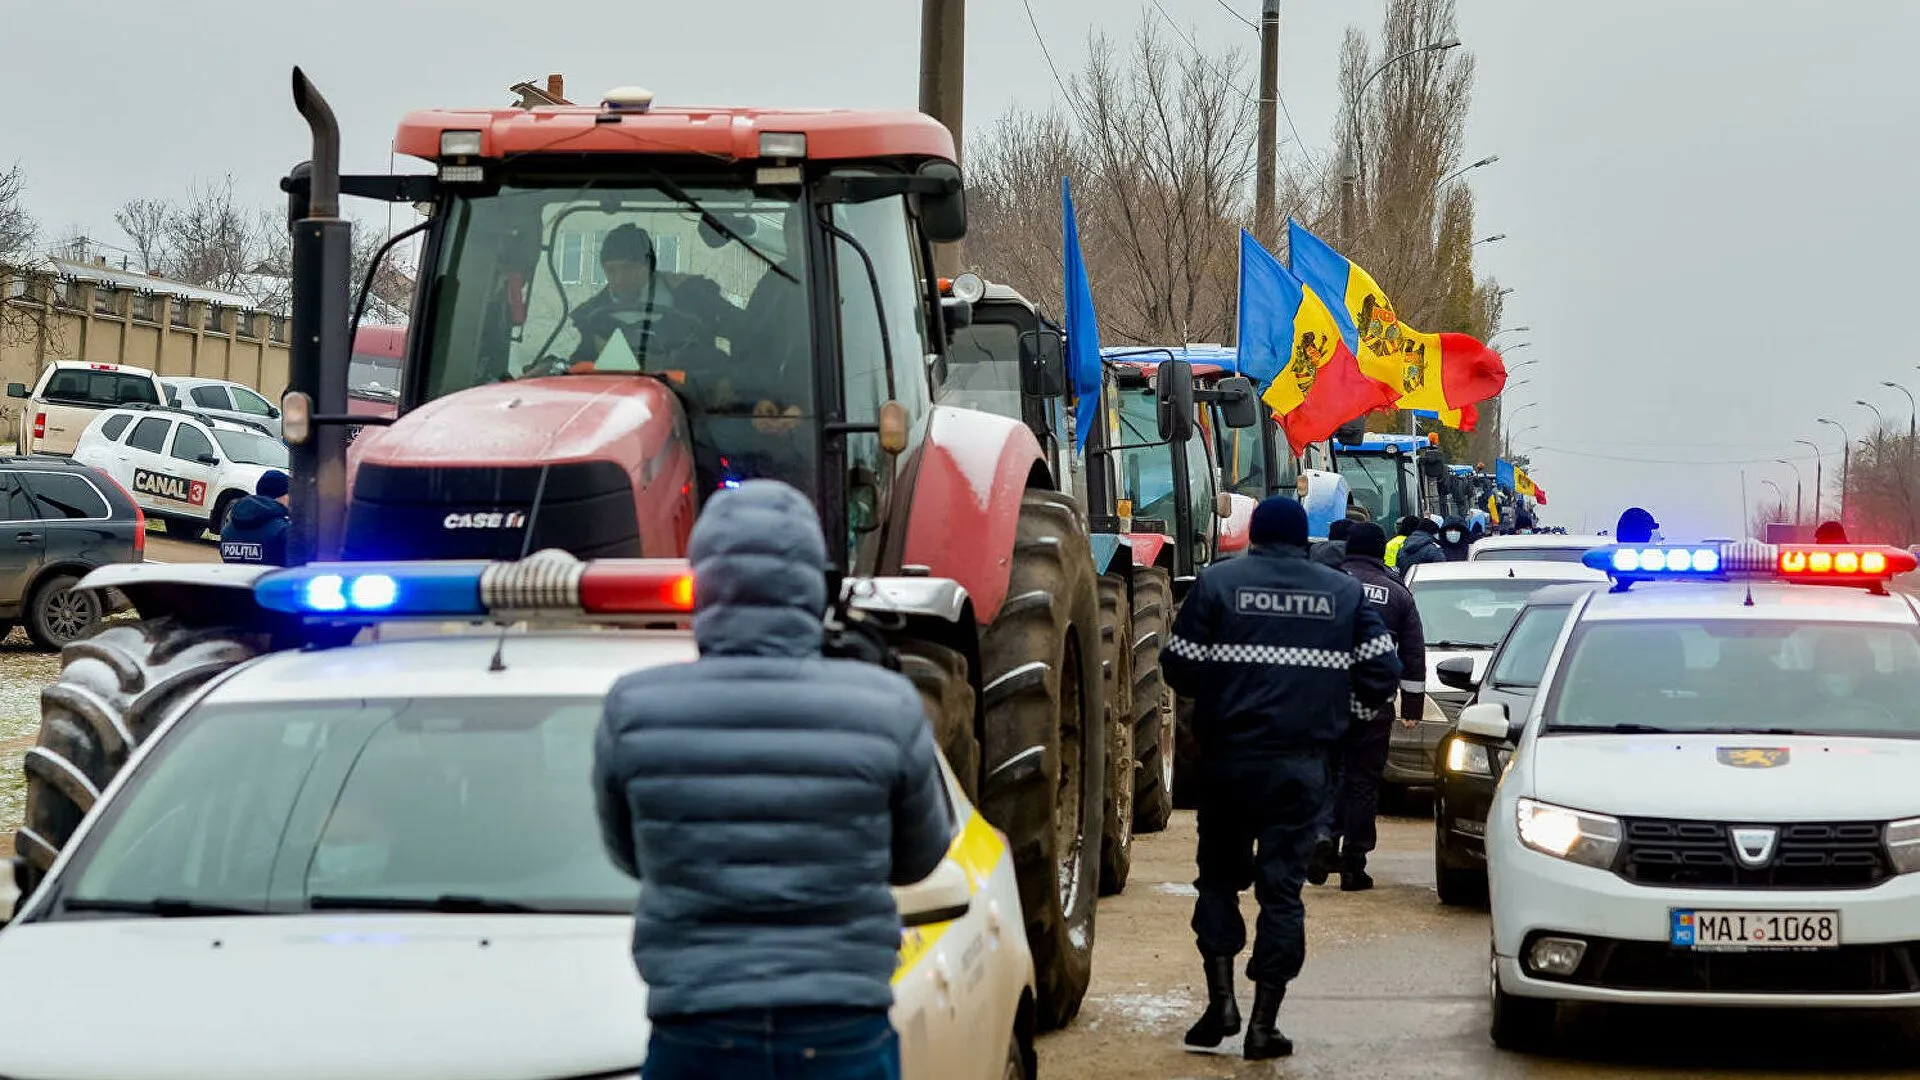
(1459, 542, 1920, 1047)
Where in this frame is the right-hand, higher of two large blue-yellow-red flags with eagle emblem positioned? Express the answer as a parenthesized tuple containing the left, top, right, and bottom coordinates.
(1286, 221, 1507, 430)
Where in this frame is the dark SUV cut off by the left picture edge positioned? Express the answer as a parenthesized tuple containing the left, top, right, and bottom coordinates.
(0, 457, 146, 650)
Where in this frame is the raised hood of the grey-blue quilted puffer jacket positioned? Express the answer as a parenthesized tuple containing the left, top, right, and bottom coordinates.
(687, 480, 828, 657)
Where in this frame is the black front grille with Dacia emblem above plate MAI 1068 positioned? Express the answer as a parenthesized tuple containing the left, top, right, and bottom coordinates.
(1615, 819, 1893, 888)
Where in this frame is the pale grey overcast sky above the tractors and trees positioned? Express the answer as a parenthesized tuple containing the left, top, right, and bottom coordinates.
(0, 0, 1920, 538)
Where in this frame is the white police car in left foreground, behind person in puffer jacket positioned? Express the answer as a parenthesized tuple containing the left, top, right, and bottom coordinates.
(0, 553, 1035, 1080)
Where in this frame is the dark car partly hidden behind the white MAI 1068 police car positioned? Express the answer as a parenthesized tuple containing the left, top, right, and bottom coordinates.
(1434, 582, 1605, 905)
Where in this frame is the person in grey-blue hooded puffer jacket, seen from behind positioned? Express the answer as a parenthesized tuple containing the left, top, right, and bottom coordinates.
(593, 480, 944, 1080)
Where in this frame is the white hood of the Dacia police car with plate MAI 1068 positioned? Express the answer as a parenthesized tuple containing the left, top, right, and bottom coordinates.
(1521, 734, 1920, 821)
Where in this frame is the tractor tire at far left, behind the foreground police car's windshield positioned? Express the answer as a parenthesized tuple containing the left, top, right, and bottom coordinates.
(13, 619, 265, 882)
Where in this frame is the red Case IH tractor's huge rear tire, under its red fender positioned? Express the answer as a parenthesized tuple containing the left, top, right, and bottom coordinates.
(979, 490, 1106, 1030)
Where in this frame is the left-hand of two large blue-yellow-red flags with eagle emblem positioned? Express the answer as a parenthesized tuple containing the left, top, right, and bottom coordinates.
(1236, 229, 1394, 454)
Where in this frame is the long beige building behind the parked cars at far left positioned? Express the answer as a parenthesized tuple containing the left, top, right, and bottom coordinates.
(0, 258, 288, 402)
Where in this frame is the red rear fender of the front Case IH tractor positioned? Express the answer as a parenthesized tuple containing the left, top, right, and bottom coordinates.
(899, 405, 1052, 626)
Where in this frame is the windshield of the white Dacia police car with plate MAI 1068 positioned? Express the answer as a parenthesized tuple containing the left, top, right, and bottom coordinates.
(1546, 619, 1920, 738)
